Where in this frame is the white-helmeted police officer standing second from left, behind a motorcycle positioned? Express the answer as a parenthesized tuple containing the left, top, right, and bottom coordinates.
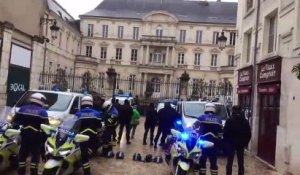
(75, 96, 102, 175)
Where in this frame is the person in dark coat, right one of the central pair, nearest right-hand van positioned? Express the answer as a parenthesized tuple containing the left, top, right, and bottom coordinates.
(154, 102, 180, 148)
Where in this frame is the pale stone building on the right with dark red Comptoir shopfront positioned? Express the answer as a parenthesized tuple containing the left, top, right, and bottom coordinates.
(235, 0, 300, 174)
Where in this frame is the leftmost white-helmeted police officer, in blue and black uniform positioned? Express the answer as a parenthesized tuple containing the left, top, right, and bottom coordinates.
(12, 93, 49, 175)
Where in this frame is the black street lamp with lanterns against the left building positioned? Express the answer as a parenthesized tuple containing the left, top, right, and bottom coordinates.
(35, 18, 60, 85)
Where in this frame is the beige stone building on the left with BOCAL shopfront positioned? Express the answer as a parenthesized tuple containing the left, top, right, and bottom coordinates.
(0, 0, 81, 107)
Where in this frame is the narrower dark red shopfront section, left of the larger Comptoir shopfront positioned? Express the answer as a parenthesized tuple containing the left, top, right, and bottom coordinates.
(237, 66, 253, 115)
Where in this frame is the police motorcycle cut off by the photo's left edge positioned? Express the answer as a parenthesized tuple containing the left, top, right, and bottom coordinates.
(0, 120, 21, 168)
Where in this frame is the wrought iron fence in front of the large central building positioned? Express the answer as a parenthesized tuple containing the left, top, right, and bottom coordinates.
(40, 70, 233, 101)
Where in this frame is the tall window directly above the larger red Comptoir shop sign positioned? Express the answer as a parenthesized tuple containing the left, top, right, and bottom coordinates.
(268, 16, 277, 53)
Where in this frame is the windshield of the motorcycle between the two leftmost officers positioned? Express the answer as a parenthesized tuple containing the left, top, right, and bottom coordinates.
(56, 118, 79, 148)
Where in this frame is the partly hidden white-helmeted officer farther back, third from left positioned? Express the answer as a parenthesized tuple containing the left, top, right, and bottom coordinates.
(102, 101, 119, 156)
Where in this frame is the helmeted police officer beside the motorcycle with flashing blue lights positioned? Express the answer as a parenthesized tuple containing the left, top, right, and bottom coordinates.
(193, 103, 222, 175)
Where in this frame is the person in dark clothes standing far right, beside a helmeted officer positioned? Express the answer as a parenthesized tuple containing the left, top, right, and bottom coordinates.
(224, 106, 251, 175)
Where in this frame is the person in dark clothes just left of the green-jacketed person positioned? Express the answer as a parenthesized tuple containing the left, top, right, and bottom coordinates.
(117, 99, 133, 144)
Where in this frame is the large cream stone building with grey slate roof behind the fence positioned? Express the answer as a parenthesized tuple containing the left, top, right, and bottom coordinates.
(76, 0, 237, 98)
